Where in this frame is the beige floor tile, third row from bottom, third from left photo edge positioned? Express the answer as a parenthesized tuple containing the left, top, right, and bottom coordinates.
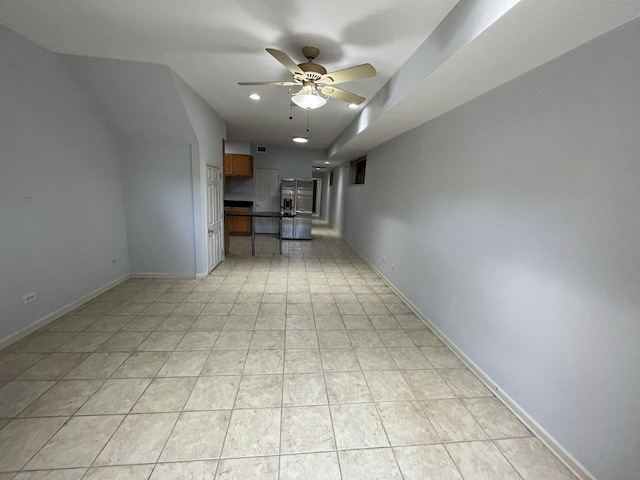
(77, 378, 151, 415)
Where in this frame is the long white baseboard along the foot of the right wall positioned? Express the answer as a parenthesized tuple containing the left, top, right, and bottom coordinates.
(340, 232, 597, 480)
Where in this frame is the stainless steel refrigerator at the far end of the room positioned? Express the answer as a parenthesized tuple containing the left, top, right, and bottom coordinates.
(280, 178, 313, 240)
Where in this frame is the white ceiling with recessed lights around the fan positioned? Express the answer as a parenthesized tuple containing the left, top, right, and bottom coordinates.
(0, 0, 640, 168)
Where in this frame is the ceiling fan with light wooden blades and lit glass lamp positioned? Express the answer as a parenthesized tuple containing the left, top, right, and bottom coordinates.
(238, 45, 376, 109)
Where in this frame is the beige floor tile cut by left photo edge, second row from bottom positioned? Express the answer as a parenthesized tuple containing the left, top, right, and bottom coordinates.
(0, 417, 67, 472)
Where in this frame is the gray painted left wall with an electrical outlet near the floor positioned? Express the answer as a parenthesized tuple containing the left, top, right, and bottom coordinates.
(0, 26, 129, 340)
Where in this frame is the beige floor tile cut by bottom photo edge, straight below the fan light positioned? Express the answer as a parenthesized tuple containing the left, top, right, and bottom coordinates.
(280, 452, 342, 480)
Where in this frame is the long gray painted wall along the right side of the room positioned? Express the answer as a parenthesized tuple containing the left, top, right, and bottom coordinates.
(329, 17, 640, 480)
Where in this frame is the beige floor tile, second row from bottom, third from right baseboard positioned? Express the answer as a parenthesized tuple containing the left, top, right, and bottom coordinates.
(376, 402, 440, 446)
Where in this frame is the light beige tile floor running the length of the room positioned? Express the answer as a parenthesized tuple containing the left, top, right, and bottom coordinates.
(0, 220, 574, 480)
